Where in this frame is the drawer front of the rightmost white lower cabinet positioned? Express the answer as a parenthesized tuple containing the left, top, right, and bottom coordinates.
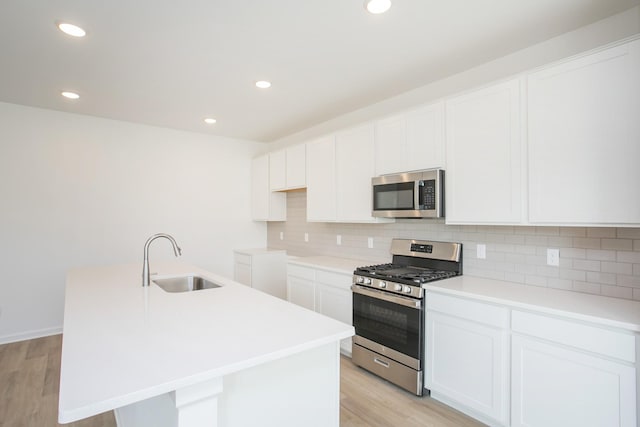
(511, 311, 636, 362)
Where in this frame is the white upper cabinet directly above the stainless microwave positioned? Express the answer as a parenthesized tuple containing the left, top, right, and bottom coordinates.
(375, 102, 444, 175)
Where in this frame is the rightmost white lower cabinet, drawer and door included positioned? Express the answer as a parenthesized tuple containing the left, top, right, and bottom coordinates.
(511, 311, 637, 427)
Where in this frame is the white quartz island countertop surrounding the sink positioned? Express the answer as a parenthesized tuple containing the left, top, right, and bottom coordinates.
(59, 262, 354, 423)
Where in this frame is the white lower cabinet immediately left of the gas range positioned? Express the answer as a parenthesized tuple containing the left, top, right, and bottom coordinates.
(287, 264, 353, 355)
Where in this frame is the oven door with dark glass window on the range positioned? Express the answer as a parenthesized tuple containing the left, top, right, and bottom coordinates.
(351, 284, 424, 369)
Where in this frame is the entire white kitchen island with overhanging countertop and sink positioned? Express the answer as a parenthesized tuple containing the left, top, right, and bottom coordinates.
(58, 262, 354, 427)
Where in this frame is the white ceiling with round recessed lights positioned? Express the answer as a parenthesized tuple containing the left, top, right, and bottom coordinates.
(0, 0, 638, 142)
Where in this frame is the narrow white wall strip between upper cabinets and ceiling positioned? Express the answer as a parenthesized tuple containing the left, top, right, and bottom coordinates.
(270, 6, 640, 149)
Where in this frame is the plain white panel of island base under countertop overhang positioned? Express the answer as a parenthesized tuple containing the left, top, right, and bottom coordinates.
(218, 342, 340, 427)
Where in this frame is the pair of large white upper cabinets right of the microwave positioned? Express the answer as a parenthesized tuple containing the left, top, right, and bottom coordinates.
(445, 40, 640, 226)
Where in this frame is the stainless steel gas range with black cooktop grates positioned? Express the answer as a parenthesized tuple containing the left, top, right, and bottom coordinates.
(351, 239, 462, 396)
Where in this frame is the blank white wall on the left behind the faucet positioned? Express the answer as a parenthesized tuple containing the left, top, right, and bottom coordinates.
(0, 103, 266, 343)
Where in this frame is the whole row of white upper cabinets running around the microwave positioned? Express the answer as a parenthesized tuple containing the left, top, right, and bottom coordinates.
(254, 40, 640, 226)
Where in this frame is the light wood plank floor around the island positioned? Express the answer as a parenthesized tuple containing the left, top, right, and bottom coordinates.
(0, 335, 484, 427)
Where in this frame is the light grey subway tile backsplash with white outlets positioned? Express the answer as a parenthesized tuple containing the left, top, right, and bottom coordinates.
(267, 191, 640, 300)
